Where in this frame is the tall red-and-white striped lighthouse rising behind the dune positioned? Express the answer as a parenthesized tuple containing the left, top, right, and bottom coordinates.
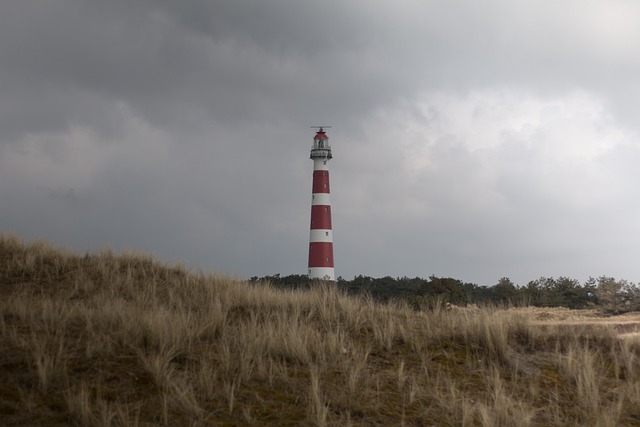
(309, 126, 336, 282)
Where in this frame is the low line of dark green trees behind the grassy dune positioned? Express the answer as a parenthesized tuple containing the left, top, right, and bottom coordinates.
(249, 274, 640, 314)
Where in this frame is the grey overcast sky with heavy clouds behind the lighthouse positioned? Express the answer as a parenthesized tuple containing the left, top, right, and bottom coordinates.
(0, 0, 640, 285)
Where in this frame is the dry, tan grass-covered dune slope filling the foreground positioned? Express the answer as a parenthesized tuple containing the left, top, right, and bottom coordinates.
(0, 235, 640, 426)
